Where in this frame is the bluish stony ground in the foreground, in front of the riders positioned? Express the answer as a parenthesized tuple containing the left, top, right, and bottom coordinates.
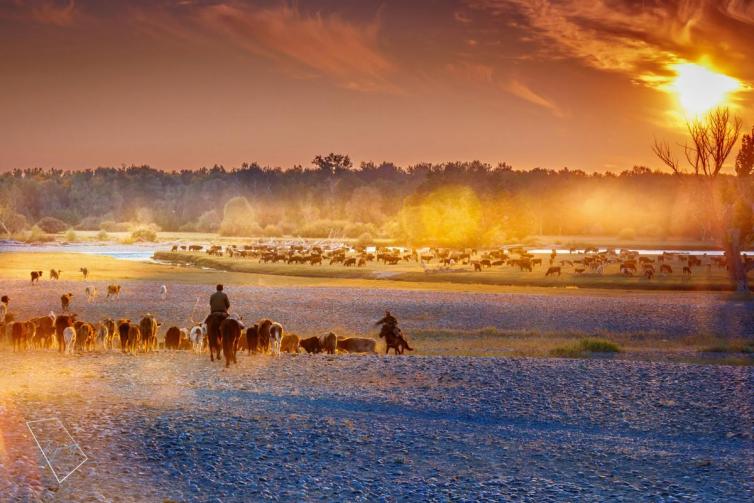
(0, 352, 754, 502)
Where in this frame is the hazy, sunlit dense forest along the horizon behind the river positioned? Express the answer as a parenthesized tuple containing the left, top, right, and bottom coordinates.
(0, 154, 724, 245)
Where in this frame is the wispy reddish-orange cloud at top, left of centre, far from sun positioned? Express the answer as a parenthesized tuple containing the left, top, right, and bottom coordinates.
(132, 2, 399, 93)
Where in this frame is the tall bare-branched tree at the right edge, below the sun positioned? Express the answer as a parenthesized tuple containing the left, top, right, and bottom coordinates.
(652, 108, 754, 292)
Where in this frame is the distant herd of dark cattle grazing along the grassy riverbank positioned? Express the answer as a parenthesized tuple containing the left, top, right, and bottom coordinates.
(171, 244, 727, 279)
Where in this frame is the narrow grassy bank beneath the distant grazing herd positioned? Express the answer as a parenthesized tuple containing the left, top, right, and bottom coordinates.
(155, 252, 754, 291)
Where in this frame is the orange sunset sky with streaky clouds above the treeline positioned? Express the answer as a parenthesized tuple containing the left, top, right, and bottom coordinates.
(0, 0, 754, 171)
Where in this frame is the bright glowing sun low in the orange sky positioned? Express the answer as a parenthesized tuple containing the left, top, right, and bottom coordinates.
(670, 63, 741, 117)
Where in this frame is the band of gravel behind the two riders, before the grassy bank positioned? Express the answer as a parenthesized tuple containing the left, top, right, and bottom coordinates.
(2, 280, 754, 337)
